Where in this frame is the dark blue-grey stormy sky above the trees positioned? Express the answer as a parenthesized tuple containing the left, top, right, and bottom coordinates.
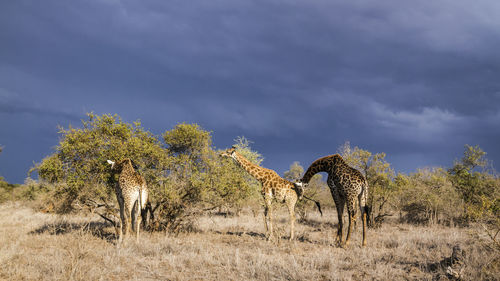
(0, 0, 500, 183)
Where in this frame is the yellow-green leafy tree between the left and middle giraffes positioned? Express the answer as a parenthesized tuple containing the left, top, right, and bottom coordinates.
(163, 127, 263, 221)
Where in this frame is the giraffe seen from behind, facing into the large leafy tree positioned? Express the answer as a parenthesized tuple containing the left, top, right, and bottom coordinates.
(108, 158, 148, 243)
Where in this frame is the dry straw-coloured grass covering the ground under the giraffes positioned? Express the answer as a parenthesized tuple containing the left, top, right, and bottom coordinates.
(0, 200, 500, 280)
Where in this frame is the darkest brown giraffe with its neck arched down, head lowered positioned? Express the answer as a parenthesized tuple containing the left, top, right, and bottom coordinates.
(295, 154, 368, 246)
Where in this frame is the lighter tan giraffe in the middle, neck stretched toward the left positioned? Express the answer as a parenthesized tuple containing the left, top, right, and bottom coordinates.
(221, 146, 303, 241)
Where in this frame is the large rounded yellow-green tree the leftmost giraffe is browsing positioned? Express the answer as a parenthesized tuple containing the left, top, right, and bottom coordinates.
(30, 110, 170, 212)
